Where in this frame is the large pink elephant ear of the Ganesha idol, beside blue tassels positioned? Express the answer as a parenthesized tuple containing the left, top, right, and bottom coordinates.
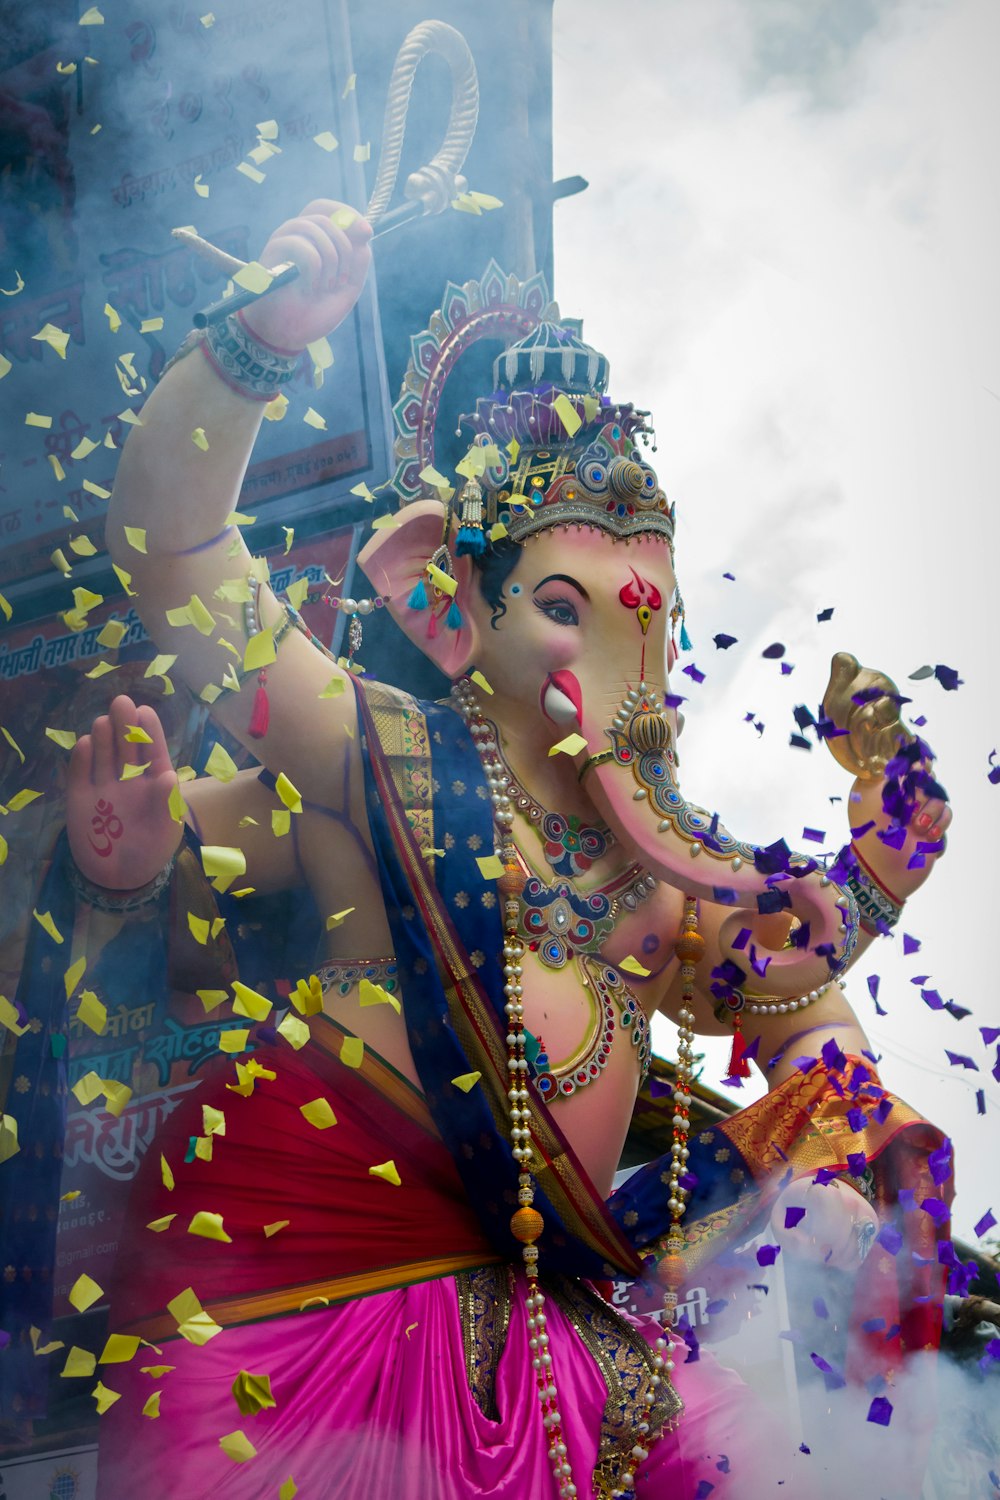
(358, 500, 480, 678)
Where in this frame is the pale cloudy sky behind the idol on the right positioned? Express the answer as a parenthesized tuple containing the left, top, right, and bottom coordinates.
(553, 0, 1000, 1244)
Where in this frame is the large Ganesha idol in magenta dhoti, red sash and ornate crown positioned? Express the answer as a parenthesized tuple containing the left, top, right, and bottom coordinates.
(9, 201, 949, 1500)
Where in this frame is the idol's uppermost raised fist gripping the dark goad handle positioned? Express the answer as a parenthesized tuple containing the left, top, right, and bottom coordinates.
(243, 198, 372, 350)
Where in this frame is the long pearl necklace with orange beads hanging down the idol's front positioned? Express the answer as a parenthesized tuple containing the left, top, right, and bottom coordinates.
(454, 678, 689, 1500)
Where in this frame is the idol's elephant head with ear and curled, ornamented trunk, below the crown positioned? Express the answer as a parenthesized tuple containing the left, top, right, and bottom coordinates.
(360, 489, 852, 996)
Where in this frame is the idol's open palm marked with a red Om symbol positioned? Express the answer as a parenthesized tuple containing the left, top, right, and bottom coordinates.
(66, 695, 183, 891)
